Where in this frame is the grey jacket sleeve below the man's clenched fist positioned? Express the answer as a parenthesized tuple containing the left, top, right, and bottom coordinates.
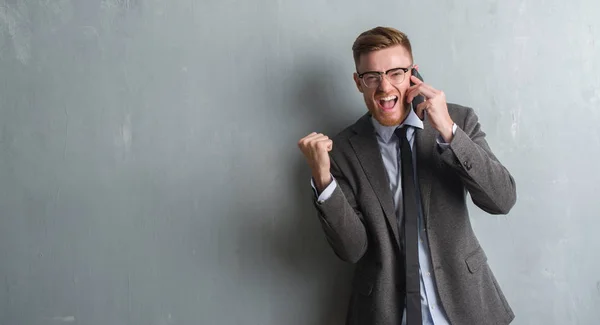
(314, 156, 368, 263)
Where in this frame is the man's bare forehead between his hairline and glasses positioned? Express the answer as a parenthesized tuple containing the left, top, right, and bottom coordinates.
(358, 45, 412, 72)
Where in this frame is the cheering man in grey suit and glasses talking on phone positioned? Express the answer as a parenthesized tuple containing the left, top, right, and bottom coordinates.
(298, 27, 516, 325)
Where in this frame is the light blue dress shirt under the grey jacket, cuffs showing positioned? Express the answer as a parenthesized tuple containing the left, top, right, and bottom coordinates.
(311, 109, 457, 325)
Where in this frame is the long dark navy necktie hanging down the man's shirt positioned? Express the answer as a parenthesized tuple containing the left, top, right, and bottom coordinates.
(395, 126, 423, 325)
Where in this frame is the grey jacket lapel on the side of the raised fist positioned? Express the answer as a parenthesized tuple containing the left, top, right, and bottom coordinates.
(349, 114, 400, 244)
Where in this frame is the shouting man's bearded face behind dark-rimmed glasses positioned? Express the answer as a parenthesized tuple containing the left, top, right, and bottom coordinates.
(354, 45, 412, 126)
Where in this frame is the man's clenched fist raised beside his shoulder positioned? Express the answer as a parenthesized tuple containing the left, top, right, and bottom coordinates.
(298, 132, 333, 193)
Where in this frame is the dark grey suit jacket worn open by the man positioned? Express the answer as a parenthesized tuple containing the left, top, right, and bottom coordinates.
(315, 104, 516, 325)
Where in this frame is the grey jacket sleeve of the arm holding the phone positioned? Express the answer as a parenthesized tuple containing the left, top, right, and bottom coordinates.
(441, 107, 517, 214)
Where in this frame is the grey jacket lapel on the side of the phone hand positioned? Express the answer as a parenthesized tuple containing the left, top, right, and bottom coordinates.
(415, 120, 438, 225)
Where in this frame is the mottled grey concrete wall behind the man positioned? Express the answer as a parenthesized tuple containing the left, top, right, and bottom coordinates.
(0, 0, 600, 325)
